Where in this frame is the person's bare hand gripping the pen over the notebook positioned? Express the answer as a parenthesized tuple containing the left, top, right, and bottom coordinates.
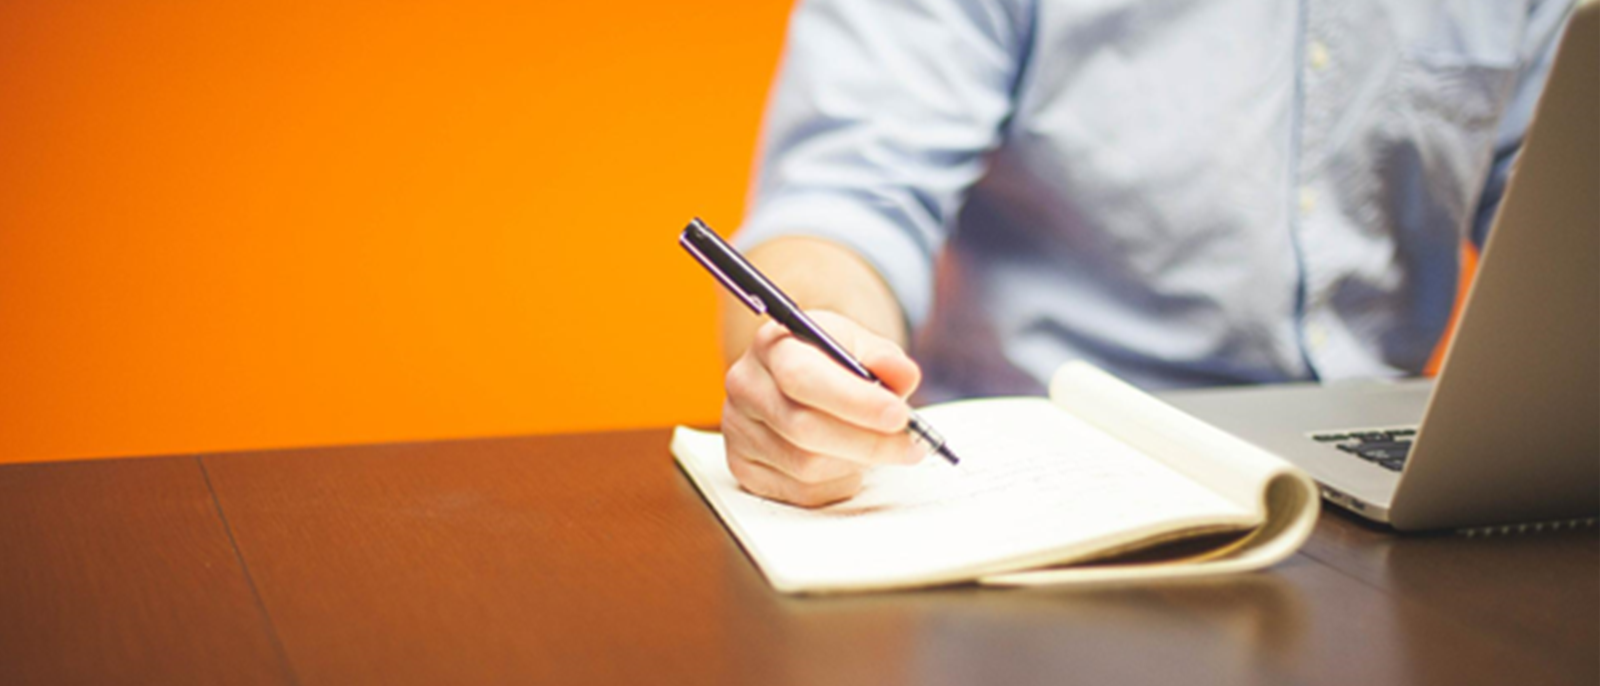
(722, 312, 926, 507)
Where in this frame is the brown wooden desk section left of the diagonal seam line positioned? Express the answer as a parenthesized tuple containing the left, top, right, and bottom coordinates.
(0, 457, 291, 684)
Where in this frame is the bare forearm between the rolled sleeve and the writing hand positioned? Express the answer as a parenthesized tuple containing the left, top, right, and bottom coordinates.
(722, 237, 907, 365)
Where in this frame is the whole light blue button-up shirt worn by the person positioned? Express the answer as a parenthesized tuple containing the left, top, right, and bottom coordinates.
(738, 0, 1571, 397)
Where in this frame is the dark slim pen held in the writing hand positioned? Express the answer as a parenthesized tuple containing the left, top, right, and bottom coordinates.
(678, 219, 962, 465)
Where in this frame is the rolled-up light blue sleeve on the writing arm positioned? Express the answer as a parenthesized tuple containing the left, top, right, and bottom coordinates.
(736, 0, 1032, 326)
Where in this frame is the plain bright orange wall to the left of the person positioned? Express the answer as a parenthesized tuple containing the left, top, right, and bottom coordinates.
(0, 0, 789, 462)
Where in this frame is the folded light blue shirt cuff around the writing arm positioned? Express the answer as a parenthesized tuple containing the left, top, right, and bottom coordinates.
(733, 193, 933, 331)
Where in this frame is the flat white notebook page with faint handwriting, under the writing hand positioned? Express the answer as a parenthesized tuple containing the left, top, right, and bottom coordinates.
(674, 398, 1256, 592)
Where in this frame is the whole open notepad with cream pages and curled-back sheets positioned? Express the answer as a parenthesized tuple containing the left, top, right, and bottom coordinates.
(672, 363, 1318, 593)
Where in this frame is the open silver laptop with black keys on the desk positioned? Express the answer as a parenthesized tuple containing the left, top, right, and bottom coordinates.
(1162, 3, 1600, 531)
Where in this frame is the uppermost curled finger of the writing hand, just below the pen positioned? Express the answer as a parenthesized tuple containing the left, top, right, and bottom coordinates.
(754, 336, 910, 433)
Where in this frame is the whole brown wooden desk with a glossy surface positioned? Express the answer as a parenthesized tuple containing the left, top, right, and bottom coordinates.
(0, 430, 1600, 686)
